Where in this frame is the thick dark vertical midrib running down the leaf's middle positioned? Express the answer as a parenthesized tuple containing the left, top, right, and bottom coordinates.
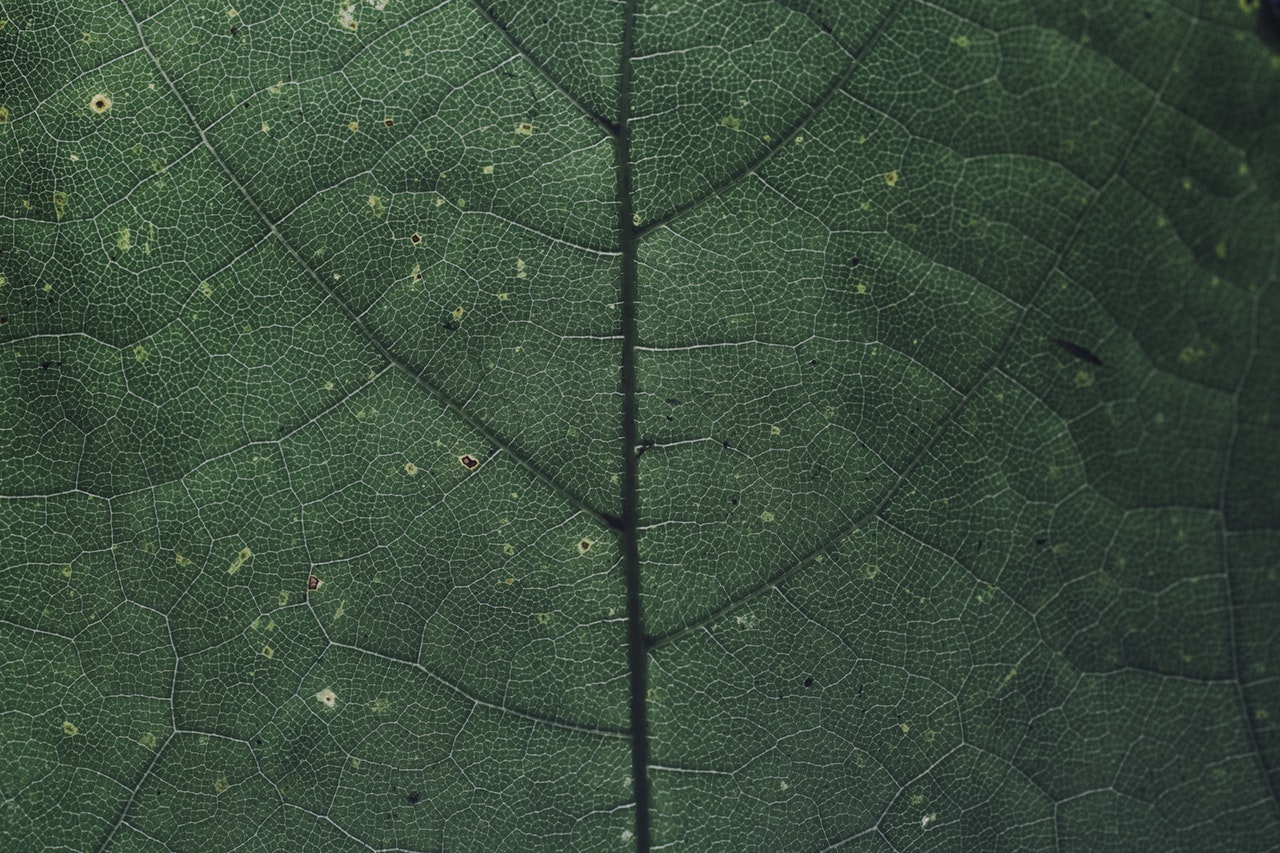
(613, 0, 649, 853)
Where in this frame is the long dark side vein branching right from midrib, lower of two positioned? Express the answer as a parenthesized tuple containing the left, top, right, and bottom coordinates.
(649, 8, 1190, 648)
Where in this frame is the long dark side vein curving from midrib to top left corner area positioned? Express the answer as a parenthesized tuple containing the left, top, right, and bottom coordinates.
(120, 0, 617, 528)
